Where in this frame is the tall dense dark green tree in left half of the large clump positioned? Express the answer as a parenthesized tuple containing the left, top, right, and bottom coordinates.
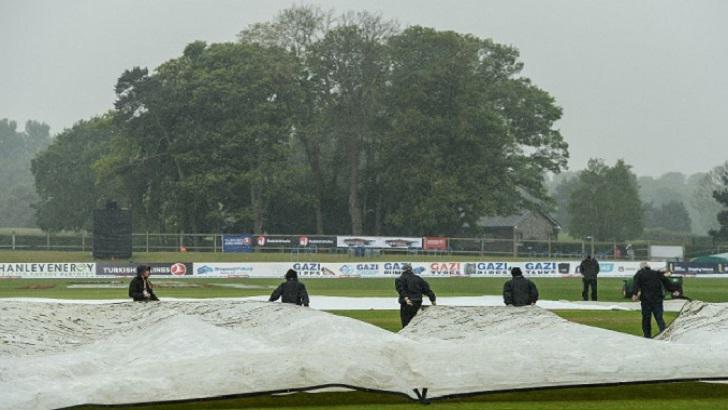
(105, 42, 302, 233)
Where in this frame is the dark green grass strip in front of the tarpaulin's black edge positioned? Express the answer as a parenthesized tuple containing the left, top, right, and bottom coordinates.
(71, 383, 728, 410)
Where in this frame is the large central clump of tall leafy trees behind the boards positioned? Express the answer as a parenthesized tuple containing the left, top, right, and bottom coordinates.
(32, 6, 568, 235)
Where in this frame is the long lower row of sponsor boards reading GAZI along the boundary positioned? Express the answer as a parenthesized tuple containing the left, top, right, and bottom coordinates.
(0, 260, 704, 278)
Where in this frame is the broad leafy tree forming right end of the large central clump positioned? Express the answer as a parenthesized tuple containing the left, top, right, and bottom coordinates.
(378, 27, 568, 235)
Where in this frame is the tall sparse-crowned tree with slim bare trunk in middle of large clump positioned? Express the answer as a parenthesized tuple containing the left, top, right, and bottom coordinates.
(311, 12, 396, 235)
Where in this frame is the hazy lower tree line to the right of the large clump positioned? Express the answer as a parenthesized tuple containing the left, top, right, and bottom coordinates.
(549, 159, 728, 240)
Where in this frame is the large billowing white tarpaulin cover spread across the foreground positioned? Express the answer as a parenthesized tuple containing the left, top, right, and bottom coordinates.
(0, 300, 728, 409)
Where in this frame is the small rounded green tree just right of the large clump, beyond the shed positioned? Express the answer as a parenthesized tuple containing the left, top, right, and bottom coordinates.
(568, 159, 644, 241)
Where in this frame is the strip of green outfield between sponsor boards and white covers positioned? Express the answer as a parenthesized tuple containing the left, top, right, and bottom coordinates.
(0, 277, 728, 302)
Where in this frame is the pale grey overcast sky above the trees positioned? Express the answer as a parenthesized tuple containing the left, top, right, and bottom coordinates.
(0, 0, 728, 176)
